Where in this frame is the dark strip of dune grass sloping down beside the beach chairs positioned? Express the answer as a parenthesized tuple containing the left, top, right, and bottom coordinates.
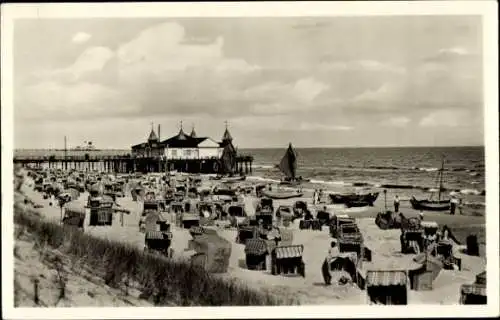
(14, 206, 297, 306)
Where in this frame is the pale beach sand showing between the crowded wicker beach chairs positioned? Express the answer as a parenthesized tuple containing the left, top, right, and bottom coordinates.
(17, 176, 486, 305)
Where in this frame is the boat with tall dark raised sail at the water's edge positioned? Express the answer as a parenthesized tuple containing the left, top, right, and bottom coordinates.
(261, 143, 303, 199)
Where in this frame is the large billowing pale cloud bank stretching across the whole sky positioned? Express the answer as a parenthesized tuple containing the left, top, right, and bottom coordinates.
(16, 22, 481, 136)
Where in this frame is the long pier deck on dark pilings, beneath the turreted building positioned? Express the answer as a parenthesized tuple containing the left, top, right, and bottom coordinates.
(14, 154, 253, 174)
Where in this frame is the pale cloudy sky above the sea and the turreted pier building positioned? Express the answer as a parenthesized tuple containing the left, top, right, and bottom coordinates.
(14, 16, 484, 149)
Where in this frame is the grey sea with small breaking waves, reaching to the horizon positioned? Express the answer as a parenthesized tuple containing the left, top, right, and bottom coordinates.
(15, 147, 485, 205)
